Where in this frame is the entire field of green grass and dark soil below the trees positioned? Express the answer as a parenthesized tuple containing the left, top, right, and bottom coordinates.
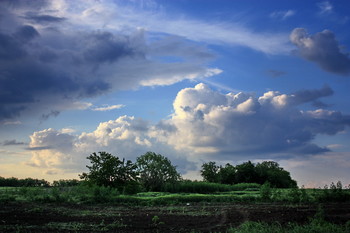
(0, 182, 350, 232)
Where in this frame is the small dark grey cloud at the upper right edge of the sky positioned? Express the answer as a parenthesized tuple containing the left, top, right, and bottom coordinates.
(290, 28, 350, 75)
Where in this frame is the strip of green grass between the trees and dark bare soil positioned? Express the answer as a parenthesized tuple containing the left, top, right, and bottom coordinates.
(0, 182, 350, 206)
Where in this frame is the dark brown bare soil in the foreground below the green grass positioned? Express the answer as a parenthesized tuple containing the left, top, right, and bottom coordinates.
(0, 203, 350, 232)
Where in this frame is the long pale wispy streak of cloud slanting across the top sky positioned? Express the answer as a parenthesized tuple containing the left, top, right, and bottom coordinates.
(62, 1, 290, 54)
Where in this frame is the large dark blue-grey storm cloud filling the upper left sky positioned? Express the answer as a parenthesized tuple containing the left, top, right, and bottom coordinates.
(0, 1, 140, 120)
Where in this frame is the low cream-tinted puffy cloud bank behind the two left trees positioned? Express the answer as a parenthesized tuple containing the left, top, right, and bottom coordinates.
(27, 116, 194, 172)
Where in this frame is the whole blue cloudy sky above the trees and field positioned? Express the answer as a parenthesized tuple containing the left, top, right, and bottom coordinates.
(0, 0, 350, 187)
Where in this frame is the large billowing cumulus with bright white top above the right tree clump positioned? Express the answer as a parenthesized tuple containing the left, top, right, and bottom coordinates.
(154, 84, 350, 157)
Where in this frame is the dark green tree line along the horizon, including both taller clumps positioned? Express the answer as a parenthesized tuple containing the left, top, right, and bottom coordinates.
(0, 152, 297, 193)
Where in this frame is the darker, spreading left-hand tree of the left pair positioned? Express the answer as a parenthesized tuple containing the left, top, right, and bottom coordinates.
(79, 152, 138, 188)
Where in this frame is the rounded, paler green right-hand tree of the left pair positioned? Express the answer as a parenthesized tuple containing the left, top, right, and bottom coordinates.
(136, 152, 181, 191)
